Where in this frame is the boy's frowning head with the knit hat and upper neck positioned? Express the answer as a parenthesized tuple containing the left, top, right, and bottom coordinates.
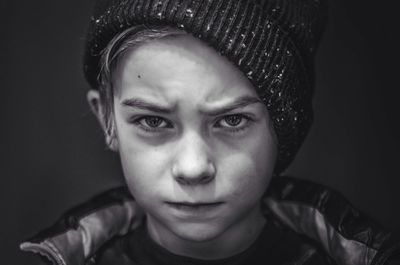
(85, 0, 322, 256)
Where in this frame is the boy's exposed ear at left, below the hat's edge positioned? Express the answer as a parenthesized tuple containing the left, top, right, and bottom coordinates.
(87, 89, 118, 151)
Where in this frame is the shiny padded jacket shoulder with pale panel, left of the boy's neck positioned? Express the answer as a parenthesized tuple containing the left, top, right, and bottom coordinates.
(20, 187, 143, 265)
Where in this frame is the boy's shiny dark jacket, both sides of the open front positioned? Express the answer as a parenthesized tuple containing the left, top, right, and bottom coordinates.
(20, 177, 400, 265)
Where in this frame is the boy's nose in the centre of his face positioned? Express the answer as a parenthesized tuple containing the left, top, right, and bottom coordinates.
(172, 132, 216, 185)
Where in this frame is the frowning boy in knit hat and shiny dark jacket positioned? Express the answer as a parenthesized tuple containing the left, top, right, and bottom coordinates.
(21, 0, 399, 265)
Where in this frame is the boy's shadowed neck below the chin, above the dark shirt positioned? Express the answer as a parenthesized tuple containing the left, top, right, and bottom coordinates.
(146, 203, 266, 260)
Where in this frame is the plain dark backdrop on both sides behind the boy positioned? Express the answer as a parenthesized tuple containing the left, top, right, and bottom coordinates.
(0, 0, 400, 265)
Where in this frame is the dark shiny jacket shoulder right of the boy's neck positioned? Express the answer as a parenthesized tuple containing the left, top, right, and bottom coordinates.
(263, 177, 400, 265)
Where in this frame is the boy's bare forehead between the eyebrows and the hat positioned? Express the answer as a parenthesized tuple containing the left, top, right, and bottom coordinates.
(113, 34, 256, 103)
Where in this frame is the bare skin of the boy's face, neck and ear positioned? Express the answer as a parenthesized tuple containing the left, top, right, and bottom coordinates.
(88, 35, 277, 259)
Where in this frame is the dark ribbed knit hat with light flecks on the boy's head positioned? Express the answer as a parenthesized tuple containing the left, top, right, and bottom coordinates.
(84, 0, 327, 173)
